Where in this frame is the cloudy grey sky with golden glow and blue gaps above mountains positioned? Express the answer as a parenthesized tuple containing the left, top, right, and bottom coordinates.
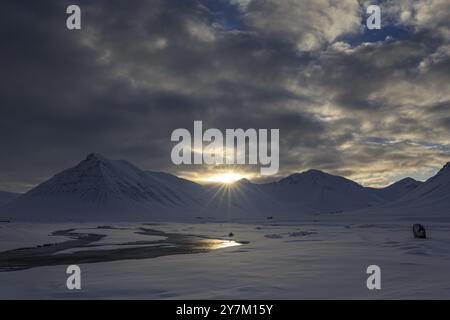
(0, 0, 450, 192)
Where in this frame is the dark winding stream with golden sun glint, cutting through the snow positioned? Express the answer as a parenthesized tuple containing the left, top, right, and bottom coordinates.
(0, 227, 248, 272)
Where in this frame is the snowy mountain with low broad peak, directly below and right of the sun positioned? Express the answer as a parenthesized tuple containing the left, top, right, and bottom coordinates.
(201, 170, 384, 217)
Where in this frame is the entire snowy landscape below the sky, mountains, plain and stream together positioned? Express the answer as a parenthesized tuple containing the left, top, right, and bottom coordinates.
(0, 154, 450, 299)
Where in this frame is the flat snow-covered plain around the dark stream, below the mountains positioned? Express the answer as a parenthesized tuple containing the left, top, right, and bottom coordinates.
(0, 217, 450, 299)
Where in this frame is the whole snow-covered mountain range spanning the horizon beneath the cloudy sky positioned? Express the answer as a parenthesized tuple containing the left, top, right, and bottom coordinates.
(0, 153, 450, 221)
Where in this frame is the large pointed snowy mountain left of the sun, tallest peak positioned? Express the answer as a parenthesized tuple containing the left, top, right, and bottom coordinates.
(3, 153, 202, 221)
